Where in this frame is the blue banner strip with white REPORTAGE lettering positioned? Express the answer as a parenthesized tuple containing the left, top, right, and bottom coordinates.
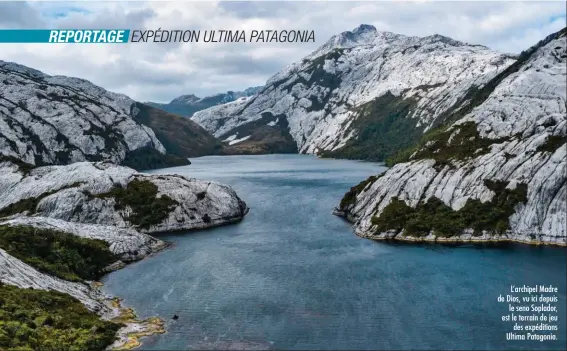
(0, 29, 130, 44)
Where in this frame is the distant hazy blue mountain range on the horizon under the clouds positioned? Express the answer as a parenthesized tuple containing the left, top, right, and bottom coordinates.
(146, 87, 262, 117)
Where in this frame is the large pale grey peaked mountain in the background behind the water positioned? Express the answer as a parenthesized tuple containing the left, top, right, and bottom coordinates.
(193, 25, 515, 160)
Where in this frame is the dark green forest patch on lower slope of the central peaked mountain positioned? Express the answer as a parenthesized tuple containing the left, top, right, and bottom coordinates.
(321, 93, 422, 162)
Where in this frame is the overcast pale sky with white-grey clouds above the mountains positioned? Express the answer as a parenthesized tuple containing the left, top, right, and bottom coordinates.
(0, 1, 566, 102)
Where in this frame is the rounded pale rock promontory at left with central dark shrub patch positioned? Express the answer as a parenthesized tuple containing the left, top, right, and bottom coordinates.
(0, 161, 248, 233)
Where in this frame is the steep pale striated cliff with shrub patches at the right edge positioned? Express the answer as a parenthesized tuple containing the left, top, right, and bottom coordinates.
(335, 29, 567, 245)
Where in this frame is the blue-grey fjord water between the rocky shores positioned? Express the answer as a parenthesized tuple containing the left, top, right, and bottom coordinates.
(104, 155, 567, 350)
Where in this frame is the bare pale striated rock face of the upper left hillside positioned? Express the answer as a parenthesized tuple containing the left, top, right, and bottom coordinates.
(0, 61, 165, 165)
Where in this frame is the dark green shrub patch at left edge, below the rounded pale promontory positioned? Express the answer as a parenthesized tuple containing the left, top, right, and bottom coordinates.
(0, 226, 119, 281)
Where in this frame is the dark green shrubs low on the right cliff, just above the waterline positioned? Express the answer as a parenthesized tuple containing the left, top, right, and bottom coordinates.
(372, 180, 528, 237)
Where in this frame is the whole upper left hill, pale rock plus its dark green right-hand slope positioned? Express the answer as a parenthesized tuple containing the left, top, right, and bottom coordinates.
(0, 61, 219, 169)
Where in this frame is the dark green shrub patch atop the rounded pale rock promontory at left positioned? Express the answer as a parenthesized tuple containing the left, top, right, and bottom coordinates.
(95, 179, 179, 229)
